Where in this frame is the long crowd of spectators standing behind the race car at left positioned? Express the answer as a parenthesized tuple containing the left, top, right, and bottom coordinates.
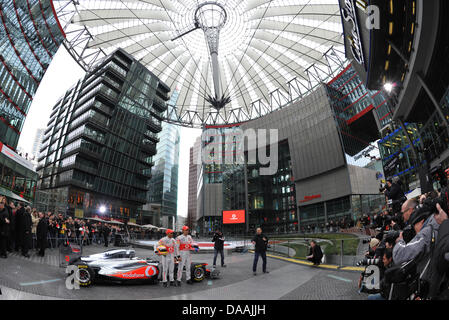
(0, 200, 173, 258)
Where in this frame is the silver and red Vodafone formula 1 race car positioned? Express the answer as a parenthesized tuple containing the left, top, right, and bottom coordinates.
(68, 249, 219, 287)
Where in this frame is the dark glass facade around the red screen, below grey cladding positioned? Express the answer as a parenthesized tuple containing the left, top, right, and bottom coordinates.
(223, 140, 298, 234)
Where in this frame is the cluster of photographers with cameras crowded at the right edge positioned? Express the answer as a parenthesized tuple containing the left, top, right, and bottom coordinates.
(359, 180, 449, 300)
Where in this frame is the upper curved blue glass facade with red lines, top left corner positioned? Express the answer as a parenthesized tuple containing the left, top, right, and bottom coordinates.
(0, 0, 65, 150)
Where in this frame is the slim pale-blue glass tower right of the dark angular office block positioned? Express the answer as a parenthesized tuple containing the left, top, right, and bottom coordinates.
(148, 122, 180, 228)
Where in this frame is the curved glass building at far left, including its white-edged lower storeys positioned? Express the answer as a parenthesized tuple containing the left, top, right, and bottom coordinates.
(0, 0, 65, 202)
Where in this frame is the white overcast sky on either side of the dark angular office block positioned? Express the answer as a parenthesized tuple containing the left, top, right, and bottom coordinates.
(18, 46, 201, 217)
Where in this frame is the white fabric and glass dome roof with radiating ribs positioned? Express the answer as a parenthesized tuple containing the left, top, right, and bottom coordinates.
(54, 0, 345, 126)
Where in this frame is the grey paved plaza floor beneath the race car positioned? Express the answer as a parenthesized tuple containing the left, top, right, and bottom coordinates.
(0, 245, 366, 300)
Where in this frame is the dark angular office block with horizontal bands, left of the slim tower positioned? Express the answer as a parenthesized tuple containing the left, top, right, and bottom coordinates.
(38, 49, 170, 219)
